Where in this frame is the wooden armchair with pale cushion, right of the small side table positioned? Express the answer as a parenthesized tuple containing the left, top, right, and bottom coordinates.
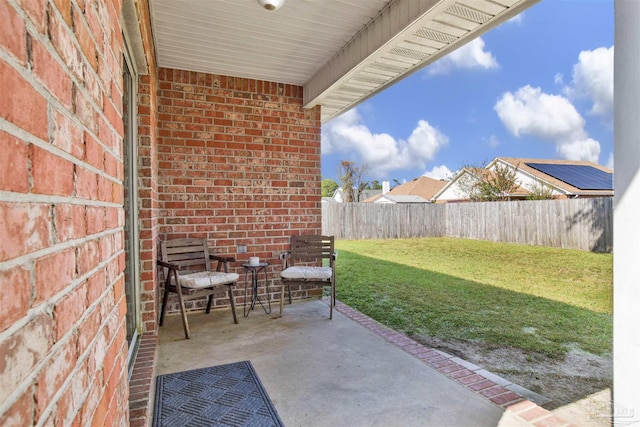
(280, 235, 337, 319)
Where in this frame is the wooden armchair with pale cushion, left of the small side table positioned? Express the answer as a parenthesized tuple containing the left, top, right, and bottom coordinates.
(158, 239, 238, 338)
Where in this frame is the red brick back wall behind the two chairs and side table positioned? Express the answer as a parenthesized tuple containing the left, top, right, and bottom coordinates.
(158, 68, 322, 312)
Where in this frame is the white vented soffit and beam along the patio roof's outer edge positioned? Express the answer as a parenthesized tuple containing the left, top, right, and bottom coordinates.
(305, 0, 538, 123)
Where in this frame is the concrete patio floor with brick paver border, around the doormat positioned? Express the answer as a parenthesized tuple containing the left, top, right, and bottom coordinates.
(155, 300, 568, 427)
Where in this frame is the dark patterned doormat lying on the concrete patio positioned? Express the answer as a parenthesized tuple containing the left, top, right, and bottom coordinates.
(153, 360, 284, 427)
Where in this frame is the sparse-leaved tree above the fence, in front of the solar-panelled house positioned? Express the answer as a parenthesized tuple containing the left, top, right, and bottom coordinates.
(458, 163, 520, 202)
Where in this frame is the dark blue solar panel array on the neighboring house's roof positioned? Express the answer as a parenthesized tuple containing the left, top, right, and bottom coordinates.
(526, 163, 613, 190)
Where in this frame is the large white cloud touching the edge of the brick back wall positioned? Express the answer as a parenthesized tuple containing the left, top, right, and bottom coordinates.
(322, 108, 449, 177)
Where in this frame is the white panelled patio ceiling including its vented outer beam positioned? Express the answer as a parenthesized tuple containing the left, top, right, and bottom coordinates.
(150, 0, 539, 123)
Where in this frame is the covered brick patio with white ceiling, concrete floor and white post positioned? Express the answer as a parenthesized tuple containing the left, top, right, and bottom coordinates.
(0, 0, 640, 426)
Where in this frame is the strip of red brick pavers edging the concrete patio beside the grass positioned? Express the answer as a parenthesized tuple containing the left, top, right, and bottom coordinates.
(324, 298, 574, 427)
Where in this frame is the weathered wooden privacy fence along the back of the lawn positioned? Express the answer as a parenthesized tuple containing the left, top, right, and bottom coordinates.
(322, 197, 613, 252)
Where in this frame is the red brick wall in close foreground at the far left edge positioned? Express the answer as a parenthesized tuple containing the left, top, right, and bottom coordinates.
(0, 0, 128, 426)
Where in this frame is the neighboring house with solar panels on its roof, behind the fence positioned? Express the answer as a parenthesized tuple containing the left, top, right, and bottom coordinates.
(433, 157, 613, 203)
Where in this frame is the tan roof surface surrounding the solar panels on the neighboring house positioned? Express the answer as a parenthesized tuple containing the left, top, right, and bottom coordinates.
(496, 157, 613, 196)
